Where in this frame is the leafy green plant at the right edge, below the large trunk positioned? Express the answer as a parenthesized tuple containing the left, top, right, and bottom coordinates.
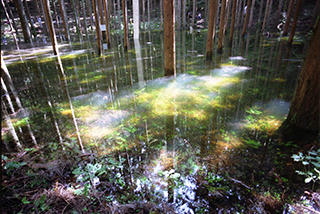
(291, 149, 320, 190)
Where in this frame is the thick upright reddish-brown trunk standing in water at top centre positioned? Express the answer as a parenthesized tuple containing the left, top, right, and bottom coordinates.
(163, 0, 176, 76)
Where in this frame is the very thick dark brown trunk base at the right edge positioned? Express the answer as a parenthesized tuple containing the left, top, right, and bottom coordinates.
(287, 21, 320, 130)
